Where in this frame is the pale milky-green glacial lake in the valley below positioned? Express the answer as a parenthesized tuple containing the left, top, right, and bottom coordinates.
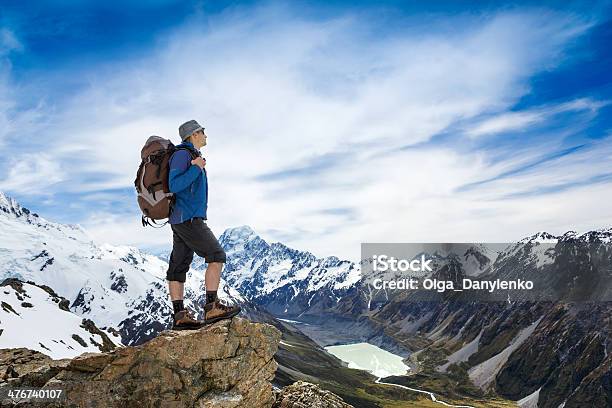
(325, 343, 410, 377)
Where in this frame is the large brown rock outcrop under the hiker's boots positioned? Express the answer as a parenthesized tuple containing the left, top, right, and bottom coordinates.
(0, 318, 280, 408)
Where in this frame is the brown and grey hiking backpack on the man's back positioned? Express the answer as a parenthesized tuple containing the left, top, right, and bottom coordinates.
(134, 136, 198, 227)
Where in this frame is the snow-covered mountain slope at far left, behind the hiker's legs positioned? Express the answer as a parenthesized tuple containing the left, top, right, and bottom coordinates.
(0, 192, 244, 345)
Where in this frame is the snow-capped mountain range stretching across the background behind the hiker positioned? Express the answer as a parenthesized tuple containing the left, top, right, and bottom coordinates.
(0, 193, 612, 408)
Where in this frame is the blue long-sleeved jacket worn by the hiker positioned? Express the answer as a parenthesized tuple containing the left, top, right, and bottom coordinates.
(168, 142, 208, 224)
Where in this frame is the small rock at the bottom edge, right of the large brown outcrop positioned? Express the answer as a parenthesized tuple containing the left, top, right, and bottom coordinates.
(274, 381, 353, 408)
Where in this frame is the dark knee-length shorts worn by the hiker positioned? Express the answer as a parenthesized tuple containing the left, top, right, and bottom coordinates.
(166, 218, 225, 282)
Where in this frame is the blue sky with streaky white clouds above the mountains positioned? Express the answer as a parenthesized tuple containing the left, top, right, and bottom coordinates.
(0, 0, 612, 259)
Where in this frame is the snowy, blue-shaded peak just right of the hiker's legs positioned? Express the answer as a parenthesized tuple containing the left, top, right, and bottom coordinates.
(160, 226, 361, 317)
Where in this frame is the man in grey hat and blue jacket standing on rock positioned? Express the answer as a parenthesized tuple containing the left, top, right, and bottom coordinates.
(166, 120, 240, 330)
